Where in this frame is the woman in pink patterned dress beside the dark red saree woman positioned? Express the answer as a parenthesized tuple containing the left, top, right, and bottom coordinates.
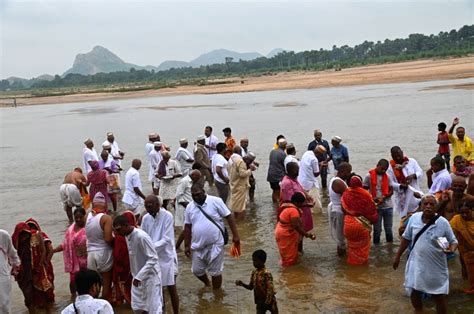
(54, 208, 87, 297)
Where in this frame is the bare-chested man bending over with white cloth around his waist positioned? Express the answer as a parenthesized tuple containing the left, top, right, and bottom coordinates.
(59, 168, 87, 224)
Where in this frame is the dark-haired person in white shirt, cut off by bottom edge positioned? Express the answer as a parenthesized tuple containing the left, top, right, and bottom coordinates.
(60, 269, 114, 314)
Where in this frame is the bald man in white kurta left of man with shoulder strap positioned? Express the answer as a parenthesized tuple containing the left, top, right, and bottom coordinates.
(141, 195, 179, 314)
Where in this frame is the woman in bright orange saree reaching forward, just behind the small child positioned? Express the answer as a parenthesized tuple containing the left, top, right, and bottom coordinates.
(275, 193, 316, 267)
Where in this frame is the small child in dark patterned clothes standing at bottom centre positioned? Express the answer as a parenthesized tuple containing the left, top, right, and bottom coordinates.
(235, 250, 278, 314)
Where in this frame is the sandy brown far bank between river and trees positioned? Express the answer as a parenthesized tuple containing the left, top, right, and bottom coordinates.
(0, 56, 474, 107)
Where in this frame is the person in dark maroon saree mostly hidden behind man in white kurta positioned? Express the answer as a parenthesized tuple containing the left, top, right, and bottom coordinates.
(112, 211, 137, 304)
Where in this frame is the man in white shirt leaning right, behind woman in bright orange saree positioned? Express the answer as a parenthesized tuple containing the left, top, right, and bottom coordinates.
(298, 145, 324, 213)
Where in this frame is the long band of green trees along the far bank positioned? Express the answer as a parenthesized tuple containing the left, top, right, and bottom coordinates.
(0, 25, 474, 91)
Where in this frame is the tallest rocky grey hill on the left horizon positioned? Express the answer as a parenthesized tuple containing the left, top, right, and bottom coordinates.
(63, 46, 157, 76)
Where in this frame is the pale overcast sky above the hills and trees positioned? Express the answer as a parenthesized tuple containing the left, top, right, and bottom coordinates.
(0, 0, 474, 78)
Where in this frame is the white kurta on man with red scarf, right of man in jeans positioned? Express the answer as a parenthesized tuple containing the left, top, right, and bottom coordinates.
(387, 158, 423, 217)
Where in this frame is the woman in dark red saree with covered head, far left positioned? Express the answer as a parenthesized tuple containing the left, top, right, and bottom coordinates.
(12, 221, 54, 312)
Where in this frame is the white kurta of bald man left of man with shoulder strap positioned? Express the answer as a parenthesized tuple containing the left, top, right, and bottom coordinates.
(141, 208, 178, 287)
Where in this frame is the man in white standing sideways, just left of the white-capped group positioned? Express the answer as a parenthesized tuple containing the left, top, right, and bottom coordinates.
(122, 159, 145, 216)
